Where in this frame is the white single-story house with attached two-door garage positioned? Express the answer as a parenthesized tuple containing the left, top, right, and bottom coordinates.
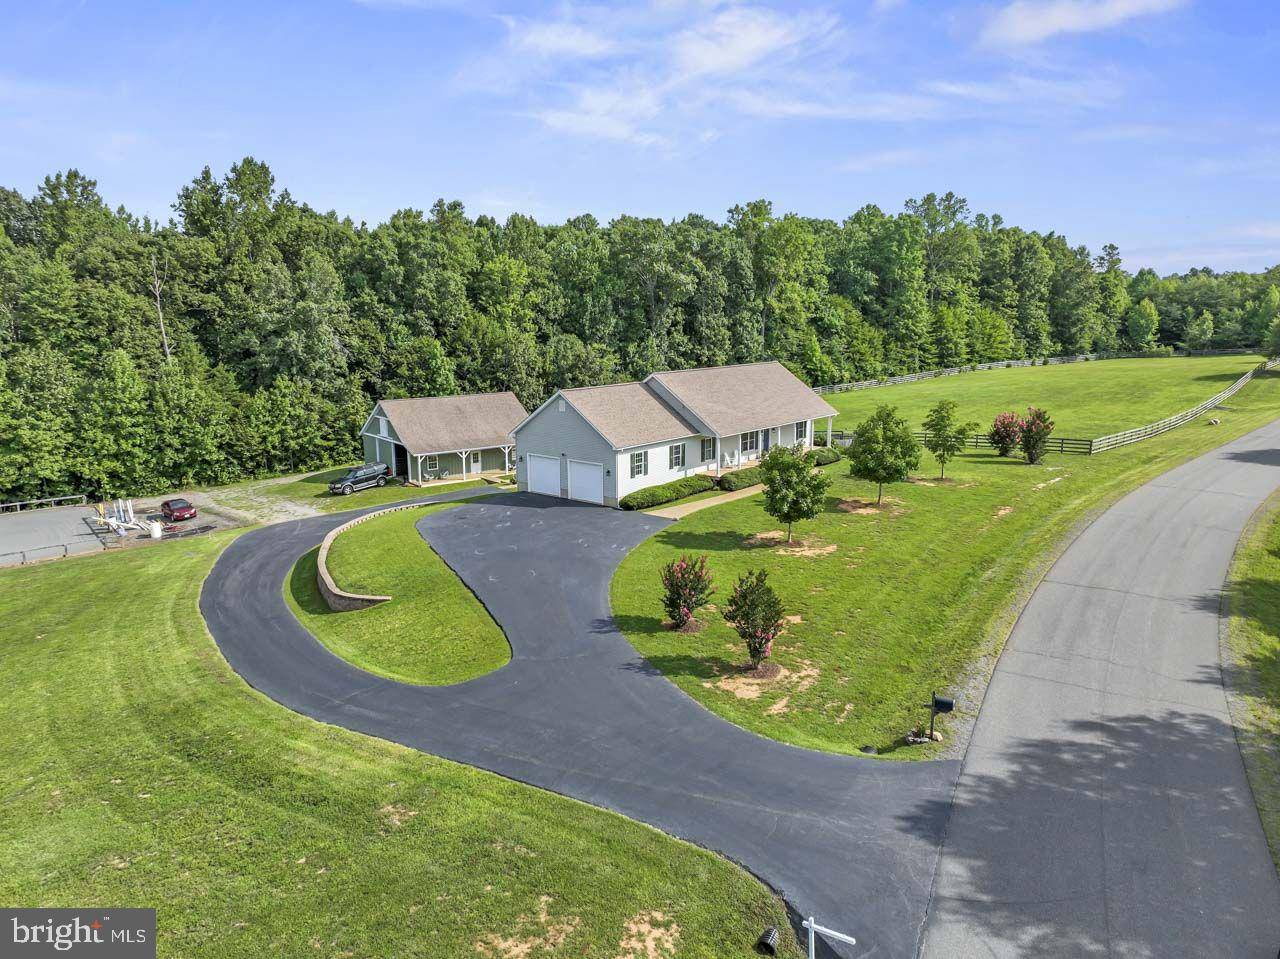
(512, 362, 836, 506)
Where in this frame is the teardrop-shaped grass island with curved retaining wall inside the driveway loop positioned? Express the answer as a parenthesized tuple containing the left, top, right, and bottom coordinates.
(284, 504, 511, 685)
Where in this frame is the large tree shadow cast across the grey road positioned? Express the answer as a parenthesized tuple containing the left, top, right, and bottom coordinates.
(900, 709, 1280, 956)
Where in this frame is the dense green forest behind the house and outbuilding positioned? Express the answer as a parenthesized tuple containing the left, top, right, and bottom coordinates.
(0, 157, 1280, 501)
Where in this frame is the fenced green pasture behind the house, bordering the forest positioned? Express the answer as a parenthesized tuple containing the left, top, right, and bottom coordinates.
(823, 356, 1262, 439)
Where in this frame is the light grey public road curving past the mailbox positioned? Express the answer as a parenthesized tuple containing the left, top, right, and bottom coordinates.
(923, 423, 1280, 959)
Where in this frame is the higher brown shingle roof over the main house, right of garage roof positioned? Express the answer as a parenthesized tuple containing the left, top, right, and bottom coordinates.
(646, 361, 836, 437)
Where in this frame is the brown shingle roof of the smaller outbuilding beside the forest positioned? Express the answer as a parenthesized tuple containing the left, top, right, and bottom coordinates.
(379, 393, 527, 453)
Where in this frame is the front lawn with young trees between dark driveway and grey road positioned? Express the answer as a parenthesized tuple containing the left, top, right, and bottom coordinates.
(612, 361, 1280, 758)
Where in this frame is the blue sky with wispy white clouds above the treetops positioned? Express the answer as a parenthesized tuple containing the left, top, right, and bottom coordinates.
(0, 0, 1280, 273)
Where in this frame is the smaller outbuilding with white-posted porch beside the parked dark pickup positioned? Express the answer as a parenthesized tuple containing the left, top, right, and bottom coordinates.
(360, 393, 529, 483)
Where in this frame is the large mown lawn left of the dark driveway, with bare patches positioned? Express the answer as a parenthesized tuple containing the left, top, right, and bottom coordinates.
(0, 534, 795, 959)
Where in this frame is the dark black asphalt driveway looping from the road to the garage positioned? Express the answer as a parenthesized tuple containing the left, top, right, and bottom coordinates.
(201, 494, 959, 958)
